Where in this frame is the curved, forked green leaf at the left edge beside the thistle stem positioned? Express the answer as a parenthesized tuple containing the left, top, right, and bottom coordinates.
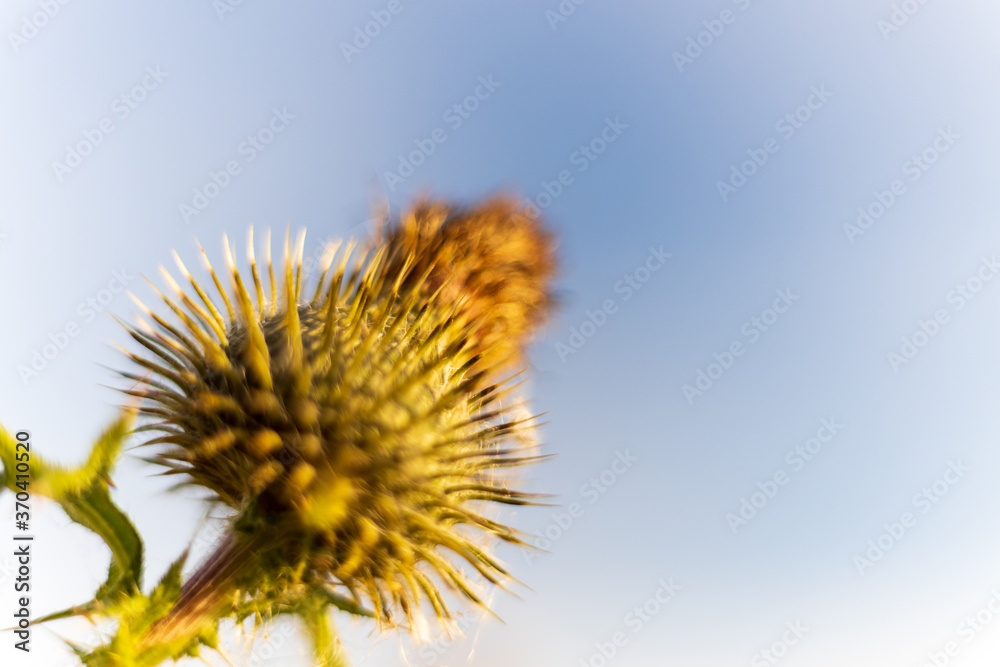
(0, 410, 143, 623)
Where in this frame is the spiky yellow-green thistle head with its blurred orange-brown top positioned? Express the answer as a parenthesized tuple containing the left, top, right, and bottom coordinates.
(125, 200, 553, 622)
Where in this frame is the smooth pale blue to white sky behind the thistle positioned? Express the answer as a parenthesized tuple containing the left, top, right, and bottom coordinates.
(0, 0, 1000, 667)
